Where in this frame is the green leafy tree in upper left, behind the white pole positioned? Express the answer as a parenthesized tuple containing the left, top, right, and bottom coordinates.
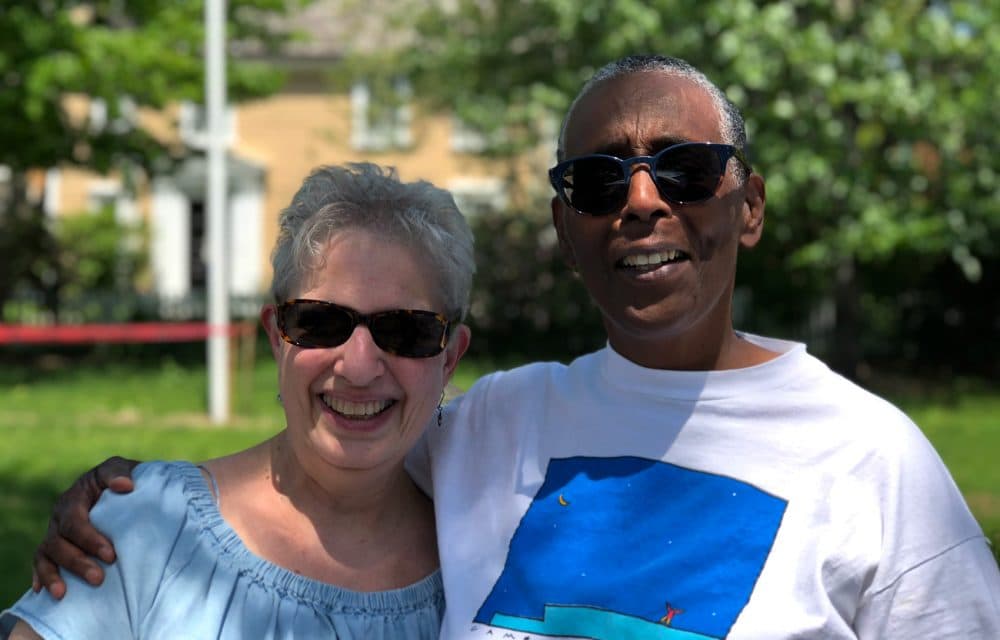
(0, 0, 305, 316)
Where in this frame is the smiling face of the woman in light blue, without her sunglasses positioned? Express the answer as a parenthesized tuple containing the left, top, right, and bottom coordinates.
(262, 231, 469, 478)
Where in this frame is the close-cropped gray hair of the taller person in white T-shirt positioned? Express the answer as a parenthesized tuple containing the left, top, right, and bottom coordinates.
(556, 55, 747, 182)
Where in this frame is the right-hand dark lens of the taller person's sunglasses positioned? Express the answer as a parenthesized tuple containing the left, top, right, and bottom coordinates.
(656, 145, 725, 202)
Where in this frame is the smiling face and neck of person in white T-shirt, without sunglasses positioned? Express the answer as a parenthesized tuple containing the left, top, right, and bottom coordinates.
(552, 71, 764, 370)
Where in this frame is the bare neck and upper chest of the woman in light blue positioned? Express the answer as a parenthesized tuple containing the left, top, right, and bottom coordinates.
(207, 433, 438, 591)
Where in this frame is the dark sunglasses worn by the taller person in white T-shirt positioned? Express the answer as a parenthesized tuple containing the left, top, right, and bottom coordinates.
(549, 142, 750, 216)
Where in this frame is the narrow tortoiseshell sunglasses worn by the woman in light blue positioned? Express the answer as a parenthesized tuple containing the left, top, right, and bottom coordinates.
(277, 299, 452, 358)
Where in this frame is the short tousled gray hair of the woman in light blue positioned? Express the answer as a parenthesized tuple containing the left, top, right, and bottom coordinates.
(271, 162, 476, 319)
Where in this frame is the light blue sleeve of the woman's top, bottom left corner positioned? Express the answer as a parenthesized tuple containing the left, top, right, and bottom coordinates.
(4, 462, 187, 640)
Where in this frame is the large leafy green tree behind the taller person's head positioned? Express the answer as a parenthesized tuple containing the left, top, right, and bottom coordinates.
(373, 0, 1000, 373)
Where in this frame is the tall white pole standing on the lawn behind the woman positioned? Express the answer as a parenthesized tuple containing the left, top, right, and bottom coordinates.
(205, 0, 229, 424)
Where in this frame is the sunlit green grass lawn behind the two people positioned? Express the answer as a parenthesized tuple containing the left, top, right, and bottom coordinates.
(0, 352, 1000, 608)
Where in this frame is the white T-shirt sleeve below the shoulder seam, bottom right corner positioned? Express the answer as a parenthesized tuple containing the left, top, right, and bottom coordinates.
(855, 536, 1000, 640)
